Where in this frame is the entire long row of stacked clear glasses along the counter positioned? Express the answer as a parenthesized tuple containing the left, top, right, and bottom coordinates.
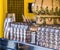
(4, 23, 60, 50)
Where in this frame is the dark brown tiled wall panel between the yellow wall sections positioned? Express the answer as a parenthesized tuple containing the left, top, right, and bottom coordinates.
(7, 0, 24, 22)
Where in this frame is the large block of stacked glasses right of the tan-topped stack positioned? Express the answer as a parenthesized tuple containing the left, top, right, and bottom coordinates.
(37, 27, 60, 49)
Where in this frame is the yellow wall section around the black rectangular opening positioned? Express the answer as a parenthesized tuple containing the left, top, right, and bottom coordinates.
(24, 0, 34, 19)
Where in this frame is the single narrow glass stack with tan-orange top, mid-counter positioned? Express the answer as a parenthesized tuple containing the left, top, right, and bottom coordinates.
(29, 26, 38, 45)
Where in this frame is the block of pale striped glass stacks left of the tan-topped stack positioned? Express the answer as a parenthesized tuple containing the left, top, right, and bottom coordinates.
(10, 23, 28, 42)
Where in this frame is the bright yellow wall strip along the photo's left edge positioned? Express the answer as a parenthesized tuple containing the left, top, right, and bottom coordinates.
(0, 0, 7, 38)
